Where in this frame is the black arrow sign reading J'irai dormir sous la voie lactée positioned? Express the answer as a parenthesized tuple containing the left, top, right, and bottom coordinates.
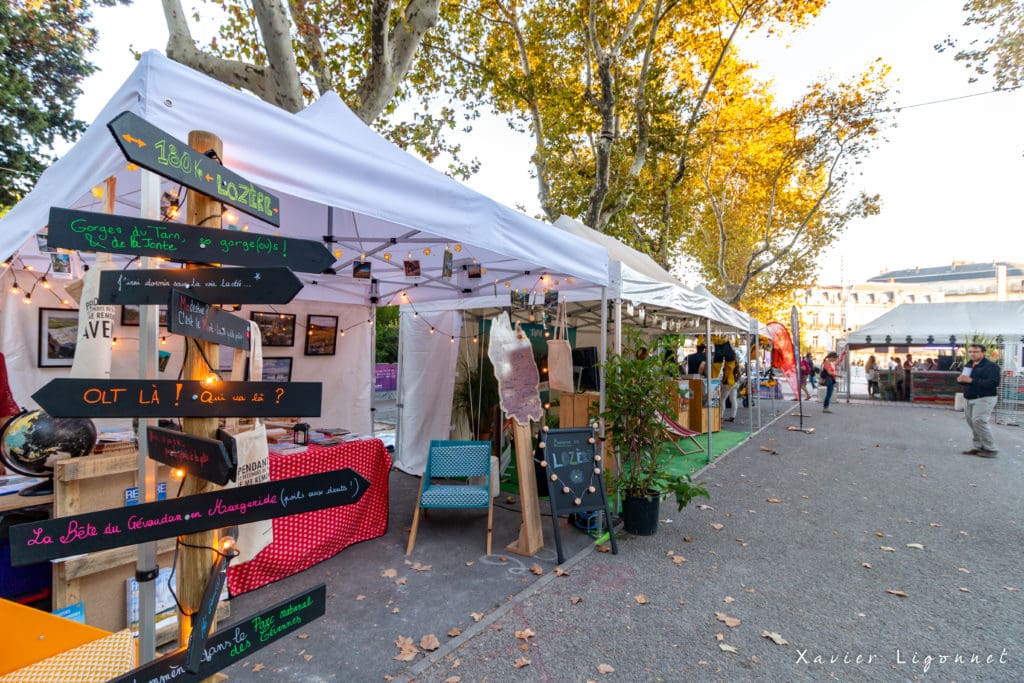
(97, 267, 302, 305)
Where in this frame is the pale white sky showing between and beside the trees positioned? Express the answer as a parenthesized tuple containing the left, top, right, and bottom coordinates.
(78, 0, 1024, 285)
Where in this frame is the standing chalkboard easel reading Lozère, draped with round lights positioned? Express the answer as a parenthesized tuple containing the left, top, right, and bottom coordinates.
(538, 427, 618, 562)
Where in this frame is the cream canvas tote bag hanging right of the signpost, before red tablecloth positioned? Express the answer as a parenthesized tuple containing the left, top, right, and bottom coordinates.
(225, 321, 273, 564)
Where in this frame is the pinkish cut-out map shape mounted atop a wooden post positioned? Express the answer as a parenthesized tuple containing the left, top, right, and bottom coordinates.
(487, 312, 544, 425)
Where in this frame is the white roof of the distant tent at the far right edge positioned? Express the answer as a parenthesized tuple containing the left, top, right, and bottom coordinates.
(847, 301, 1024, 346)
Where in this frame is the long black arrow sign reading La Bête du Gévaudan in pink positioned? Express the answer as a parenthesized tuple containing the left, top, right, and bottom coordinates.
(10, 467, 370, 566)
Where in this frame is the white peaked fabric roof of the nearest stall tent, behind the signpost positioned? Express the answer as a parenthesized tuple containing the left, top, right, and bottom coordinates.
(0, 51, 608, 304)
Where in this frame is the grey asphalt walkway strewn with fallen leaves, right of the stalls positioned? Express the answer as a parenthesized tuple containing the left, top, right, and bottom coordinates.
(401, 400, 1024, 683)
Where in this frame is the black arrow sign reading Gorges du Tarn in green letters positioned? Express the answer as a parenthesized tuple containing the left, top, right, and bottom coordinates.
(46, 207, 335, 274)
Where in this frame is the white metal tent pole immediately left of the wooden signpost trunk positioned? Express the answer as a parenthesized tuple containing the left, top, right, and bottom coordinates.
(136, 170, 160, 664)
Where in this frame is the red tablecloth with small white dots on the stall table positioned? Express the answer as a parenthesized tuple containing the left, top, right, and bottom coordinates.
(227, 438, 391, 596)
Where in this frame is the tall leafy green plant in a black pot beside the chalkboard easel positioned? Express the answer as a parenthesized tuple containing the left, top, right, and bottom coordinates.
(599, 332, 711, 536)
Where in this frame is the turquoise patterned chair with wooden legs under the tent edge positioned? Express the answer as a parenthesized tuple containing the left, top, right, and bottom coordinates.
(406, 440, 495, 555)
